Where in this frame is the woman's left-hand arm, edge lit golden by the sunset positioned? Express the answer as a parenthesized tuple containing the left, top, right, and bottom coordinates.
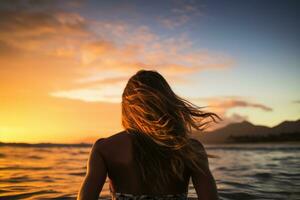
(77, 138, 107, 200)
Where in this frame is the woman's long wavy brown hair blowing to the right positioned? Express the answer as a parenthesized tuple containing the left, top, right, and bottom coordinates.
(122, 70, 220, 191)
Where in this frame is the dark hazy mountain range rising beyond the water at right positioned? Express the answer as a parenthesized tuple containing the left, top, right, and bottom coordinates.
(197, 120, 300, 143)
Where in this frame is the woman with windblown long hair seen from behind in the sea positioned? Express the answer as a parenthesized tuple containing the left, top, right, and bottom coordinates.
(78, 70, 220, 200)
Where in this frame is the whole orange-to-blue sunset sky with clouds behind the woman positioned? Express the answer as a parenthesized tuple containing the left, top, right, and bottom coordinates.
(0, 0, 300, 143)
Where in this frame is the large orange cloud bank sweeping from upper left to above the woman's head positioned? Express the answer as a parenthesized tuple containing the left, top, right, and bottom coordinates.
(0, 1, 234, 102)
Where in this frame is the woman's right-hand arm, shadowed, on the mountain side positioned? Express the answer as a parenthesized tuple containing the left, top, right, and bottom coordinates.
(192, 140, 219, 200)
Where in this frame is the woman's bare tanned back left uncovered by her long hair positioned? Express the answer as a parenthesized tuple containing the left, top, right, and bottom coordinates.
(96, 131, 190, 195)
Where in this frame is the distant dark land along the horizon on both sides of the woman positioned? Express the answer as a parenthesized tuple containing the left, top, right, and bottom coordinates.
(0, 119, 300, 148)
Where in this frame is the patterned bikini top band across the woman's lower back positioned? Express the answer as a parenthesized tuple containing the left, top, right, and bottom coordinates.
(113, 192, 187, 200)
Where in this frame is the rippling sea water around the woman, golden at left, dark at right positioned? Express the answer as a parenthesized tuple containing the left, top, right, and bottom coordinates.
(0, 144, 300, 200)
